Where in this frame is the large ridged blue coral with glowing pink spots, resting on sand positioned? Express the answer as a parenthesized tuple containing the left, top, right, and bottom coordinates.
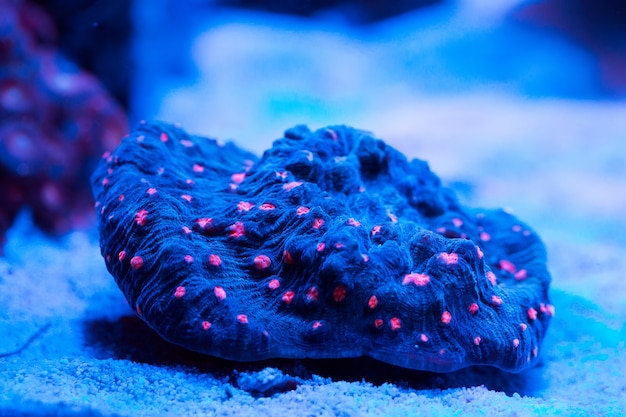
(92, 123, 554, 372)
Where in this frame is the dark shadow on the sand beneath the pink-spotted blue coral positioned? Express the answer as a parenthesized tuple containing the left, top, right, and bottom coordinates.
(84, 316, 543, 396)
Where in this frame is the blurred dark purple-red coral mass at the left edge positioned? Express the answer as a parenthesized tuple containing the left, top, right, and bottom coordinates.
(0, 0, 128, 251)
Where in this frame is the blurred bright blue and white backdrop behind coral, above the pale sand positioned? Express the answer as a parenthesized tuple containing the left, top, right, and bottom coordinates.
(130, 0, 626, 150)
